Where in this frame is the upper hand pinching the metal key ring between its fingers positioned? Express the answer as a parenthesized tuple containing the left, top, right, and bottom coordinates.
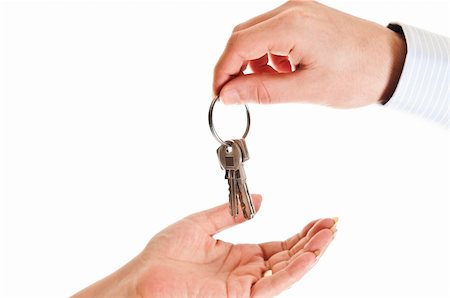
(213, 1, 406, 108)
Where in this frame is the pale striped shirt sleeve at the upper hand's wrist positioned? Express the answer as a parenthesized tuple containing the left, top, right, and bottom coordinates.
(385, 23, 450, 128)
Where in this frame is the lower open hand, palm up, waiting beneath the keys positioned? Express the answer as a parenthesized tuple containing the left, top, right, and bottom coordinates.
(77, 195, 336, 297)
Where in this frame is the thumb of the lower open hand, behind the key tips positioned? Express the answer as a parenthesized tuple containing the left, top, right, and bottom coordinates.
(188, 194, 262, 236)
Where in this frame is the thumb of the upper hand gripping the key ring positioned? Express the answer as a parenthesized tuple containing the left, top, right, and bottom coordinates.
(220, 71, 314, 104)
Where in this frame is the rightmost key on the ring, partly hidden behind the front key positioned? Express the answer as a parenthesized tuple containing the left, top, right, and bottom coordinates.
(233, 139, 256, 219)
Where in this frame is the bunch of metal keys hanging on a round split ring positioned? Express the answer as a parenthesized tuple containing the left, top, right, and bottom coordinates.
(208, 97, 255, 219)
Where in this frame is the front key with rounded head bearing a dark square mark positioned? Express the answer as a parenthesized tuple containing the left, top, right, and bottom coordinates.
(217, 141, 242, 217)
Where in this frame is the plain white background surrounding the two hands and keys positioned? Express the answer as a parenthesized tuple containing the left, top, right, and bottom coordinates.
(0, 1, 450, 297)
